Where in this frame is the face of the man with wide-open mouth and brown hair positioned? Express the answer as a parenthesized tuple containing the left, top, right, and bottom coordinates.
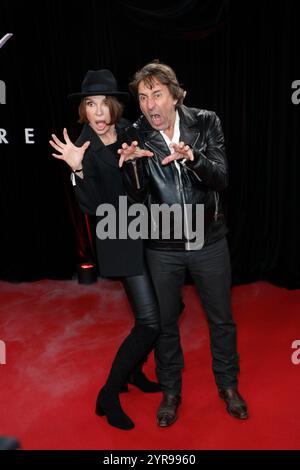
(138, 78, 177, 131)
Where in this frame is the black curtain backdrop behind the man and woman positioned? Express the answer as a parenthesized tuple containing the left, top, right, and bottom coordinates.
(0, 0, 300, 288)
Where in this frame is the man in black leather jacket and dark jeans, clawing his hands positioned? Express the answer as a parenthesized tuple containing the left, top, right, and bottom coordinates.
(118, 61, 248, 427)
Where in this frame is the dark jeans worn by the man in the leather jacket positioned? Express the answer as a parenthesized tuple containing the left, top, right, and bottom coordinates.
(147, 238, 239, 395)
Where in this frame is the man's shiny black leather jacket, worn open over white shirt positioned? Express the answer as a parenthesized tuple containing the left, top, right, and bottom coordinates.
(123, 105, 228, 250)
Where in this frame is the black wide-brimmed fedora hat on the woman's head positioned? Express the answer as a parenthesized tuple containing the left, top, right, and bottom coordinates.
(68, 69, 129, 101)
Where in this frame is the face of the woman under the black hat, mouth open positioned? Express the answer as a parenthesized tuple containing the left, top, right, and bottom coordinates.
(85, 95, 112, 136)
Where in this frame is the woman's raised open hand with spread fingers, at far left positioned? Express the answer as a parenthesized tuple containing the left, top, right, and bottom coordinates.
(49, 129, 90, 171)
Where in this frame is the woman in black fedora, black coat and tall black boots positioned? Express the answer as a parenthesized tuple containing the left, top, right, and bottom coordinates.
(50, 70, 160, 429)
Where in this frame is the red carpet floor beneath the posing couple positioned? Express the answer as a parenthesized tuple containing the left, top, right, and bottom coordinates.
(0, 281, 300, 450)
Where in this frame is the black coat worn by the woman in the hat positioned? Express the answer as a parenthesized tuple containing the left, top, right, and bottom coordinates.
(74, 120, 143, 277)
